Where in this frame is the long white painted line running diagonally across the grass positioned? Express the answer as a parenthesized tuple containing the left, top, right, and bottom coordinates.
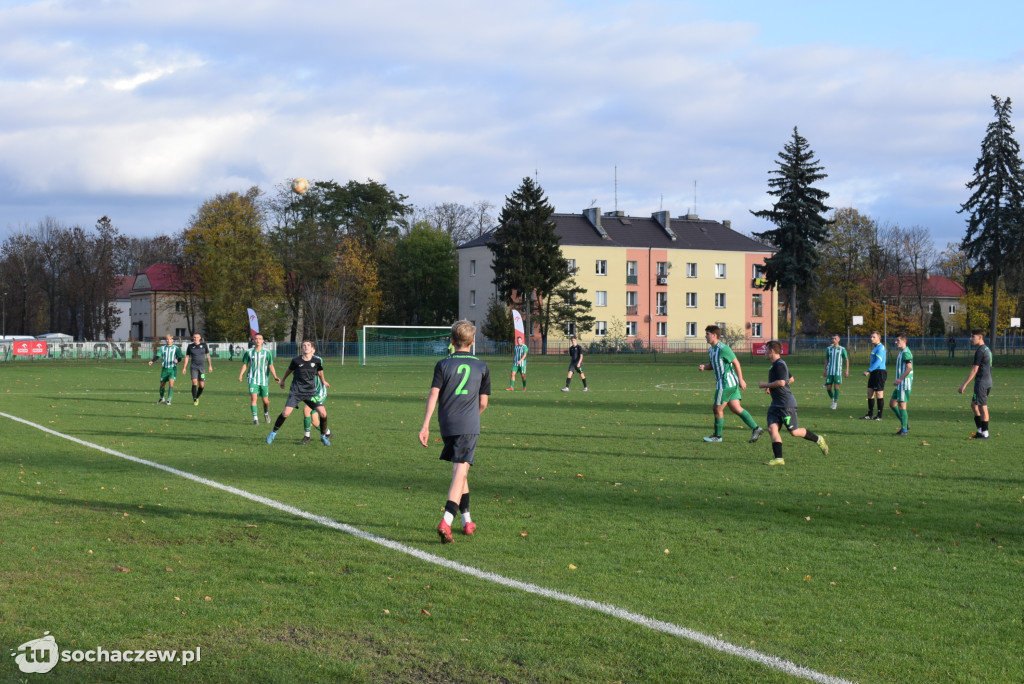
(0, 412, 853, 684)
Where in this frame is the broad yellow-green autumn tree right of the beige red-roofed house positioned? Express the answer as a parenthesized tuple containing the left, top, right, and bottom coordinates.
(183, 186, 284, 339)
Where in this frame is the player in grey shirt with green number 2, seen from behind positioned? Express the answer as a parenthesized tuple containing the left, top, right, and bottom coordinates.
(420, 320, 490, 544)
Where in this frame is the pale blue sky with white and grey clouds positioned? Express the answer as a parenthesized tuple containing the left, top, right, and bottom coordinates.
(0, 0, 1024, 250)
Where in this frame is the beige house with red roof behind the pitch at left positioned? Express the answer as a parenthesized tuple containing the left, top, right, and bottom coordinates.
(130, 263, 196, 341)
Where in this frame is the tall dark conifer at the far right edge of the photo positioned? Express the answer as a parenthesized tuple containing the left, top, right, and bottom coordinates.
(958, 95, 1024, 340)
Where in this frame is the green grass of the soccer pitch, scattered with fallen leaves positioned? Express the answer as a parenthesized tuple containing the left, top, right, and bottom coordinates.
(0, 356, 1024, 682)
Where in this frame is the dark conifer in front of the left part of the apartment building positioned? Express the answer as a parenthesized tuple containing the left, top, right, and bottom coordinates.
(488, 176, 569, 353)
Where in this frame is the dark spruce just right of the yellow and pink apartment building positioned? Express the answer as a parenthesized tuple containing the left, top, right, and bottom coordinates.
(751, 127, 831, 350)
